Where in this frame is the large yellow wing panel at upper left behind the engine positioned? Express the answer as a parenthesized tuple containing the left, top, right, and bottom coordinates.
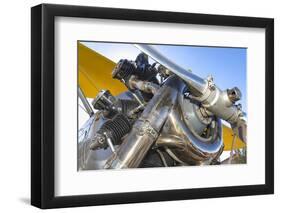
(78, 43, 127, 98)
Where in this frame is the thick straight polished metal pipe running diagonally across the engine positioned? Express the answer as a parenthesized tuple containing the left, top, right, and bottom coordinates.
(104, 76, 181, 169)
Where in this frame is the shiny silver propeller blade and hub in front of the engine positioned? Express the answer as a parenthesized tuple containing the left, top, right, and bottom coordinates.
(135, 44, 246, 142)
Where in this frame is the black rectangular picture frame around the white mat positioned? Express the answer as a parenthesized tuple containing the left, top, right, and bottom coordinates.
(31, 4, 274, 209)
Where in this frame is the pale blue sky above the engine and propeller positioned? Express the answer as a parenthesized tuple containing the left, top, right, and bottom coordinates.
(82, 42, 247, 112)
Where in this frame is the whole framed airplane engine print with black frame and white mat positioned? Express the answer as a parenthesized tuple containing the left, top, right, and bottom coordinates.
(31, 4, 274, 208)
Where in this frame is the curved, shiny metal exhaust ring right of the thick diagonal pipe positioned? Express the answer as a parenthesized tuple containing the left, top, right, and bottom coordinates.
(156, 80, 223, 165)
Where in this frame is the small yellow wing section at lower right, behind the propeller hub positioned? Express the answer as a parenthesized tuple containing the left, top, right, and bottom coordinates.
(222, 125, 245, 151)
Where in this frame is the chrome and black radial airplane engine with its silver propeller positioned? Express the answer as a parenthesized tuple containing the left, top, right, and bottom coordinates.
(78, 45, 246, 168)
